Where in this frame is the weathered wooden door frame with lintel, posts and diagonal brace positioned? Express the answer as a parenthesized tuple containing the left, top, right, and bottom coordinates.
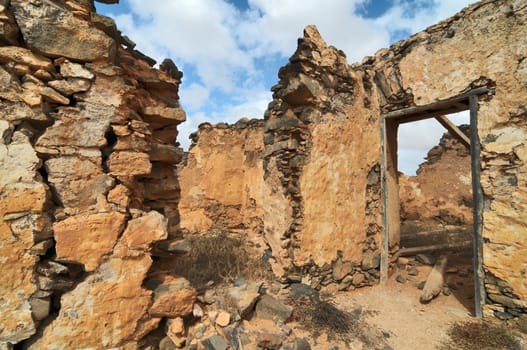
(381, 87, 488, 318)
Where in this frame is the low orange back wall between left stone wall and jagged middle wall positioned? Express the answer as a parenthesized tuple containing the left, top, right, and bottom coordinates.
(178, 119, 264, 234)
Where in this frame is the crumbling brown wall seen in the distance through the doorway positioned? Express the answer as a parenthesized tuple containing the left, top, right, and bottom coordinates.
(399, 125, 473, 226)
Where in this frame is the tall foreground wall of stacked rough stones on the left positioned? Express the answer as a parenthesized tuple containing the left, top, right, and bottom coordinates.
(0, 0, 195, 349)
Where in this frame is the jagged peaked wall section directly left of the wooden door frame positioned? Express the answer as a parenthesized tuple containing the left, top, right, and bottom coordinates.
(264, 26, 381, 289)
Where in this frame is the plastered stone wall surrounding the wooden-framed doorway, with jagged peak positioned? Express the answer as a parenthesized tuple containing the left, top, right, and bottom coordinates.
(264, 1, 527, 313)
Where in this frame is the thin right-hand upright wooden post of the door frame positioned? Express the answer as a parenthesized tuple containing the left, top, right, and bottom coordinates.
(469, 94, 486, 319)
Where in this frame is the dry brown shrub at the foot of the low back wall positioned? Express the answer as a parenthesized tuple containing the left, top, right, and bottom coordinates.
(175, 233, 272, 289)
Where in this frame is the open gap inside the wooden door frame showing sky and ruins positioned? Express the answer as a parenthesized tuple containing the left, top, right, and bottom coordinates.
(397, 110, 474, 313)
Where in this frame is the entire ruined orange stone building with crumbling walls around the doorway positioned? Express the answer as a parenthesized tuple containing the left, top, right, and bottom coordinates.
(0, 0, 527, 349)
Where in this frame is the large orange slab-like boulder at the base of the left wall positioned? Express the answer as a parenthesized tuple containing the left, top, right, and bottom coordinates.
(28, 254, 161, 350)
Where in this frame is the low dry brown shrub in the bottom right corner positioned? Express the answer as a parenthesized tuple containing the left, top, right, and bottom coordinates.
(441, 322, 522, 350)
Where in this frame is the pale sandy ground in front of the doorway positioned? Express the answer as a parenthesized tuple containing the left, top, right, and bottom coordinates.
(333, 258, 475, 350)
